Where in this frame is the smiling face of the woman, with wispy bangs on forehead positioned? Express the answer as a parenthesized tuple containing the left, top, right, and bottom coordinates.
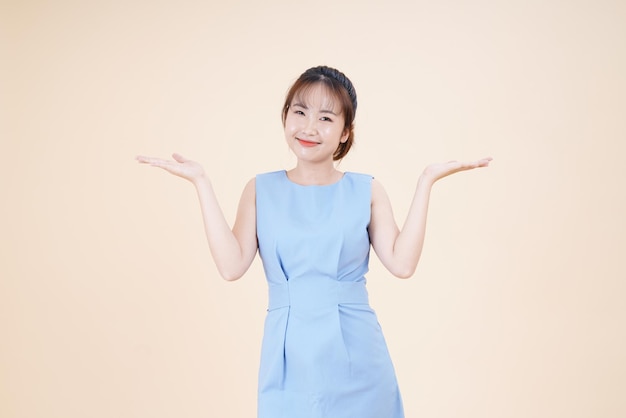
(285, 84, 349, 162)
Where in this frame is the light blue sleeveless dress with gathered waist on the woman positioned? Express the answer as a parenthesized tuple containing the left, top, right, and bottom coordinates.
(256, 171, 404, 418)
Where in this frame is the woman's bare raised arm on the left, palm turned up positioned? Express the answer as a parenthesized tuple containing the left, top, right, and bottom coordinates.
(137, 154, 257, 281)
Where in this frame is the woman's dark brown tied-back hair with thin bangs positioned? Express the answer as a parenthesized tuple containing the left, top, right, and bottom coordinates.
(282, 65, 357, 161)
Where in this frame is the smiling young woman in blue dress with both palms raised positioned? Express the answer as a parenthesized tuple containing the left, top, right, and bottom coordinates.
(137, 66, 491, 418)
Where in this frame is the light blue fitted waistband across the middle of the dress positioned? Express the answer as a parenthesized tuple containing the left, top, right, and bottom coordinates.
(268, 278, 369, 311)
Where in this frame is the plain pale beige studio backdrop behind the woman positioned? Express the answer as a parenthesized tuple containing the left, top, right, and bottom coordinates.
(0, 0, 626, 418)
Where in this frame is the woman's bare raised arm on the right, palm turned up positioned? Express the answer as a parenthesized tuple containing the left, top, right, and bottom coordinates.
(369, 158, 491, 278)
